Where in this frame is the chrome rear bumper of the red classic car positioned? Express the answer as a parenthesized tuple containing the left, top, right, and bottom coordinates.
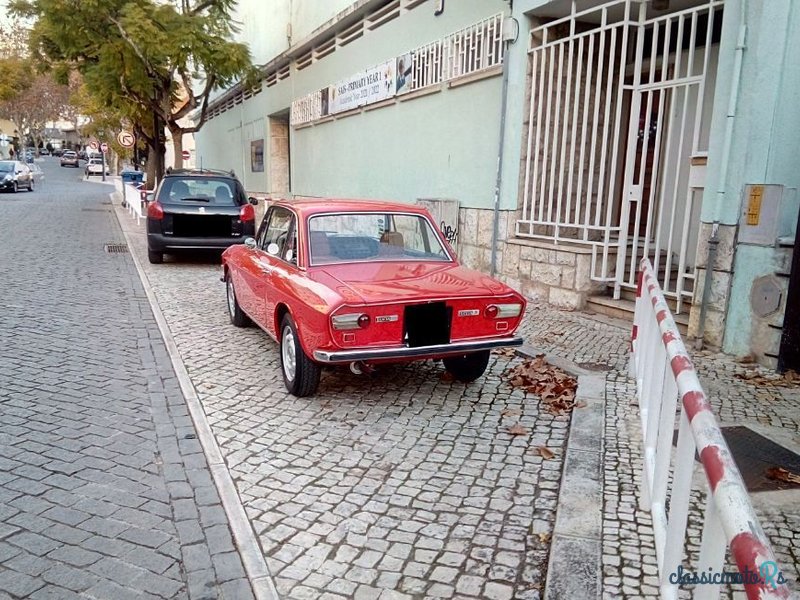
(314, 337, 523, 363)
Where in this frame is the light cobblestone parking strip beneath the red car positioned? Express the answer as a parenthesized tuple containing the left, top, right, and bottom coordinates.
(114, 195, 569, 600)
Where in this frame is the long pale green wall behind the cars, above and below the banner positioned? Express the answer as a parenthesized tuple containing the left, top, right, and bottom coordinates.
(196, 0, 506, 208)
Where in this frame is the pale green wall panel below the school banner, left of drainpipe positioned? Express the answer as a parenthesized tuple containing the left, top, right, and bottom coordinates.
(292, 78, 498, 202)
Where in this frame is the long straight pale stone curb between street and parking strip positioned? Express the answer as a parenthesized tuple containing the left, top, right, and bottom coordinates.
(109, 192, 279, 600)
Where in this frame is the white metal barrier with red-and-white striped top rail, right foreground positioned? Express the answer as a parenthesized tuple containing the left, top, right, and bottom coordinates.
(631, 259, 789, 600)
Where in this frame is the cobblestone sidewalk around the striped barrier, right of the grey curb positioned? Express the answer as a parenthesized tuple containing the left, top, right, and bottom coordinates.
(524, 306, 800, 598)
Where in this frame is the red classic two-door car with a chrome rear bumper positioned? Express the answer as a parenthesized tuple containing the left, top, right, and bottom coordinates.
(222, 199, 525, 396)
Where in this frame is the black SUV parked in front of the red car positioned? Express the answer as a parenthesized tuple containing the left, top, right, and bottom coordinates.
(147, 169, 258, 264)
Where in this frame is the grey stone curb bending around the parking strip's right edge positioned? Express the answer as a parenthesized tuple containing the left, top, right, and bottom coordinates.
(517, 346, 605, 600)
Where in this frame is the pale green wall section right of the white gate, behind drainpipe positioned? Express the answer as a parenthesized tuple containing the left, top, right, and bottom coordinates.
(701, 0, 800, 355)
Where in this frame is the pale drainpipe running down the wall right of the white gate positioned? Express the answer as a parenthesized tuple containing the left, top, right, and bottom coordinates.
(694, 0, 747, 350)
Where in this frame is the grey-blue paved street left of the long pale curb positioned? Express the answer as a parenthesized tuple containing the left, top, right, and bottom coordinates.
(0, 159, 252, 600)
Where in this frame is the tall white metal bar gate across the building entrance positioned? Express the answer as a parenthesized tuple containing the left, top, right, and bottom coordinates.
(516, 0, 722, 312)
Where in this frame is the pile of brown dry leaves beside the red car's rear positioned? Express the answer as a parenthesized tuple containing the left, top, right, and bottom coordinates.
(508, 354, 585, 415)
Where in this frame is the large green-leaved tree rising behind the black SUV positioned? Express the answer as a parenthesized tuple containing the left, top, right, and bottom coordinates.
(11, 0, 255, 181)
